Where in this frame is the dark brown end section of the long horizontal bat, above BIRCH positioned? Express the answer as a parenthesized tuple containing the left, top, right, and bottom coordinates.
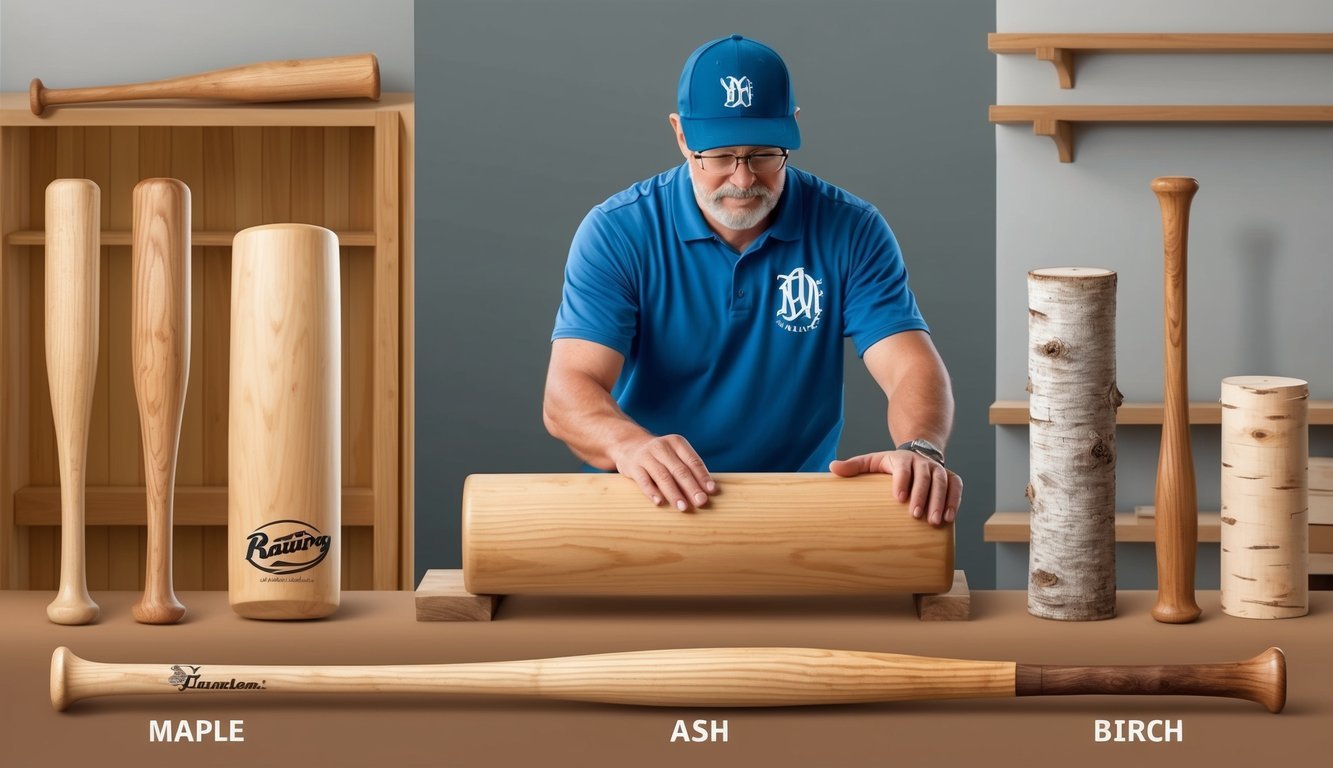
(1014, 648, 1286, 715)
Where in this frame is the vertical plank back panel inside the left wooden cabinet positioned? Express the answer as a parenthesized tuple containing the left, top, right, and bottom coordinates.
(17, 127, 375, 591)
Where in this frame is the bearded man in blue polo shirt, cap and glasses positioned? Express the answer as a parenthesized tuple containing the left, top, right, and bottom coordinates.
(544, 35, 962, 525)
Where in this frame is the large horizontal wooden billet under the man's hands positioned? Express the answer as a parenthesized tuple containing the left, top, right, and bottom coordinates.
(463, 473, 953, 595)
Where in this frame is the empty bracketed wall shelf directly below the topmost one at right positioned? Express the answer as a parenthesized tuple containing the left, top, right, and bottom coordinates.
(990, 104, 1333, 163)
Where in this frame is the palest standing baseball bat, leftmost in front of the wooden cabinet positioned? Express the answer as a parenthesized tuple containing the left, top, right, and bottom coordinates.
(45, 179, 101, 624)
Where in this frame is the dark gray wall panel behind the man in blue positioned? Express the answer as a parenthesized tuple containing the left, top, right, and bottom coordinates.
(416, 0, 996, 587)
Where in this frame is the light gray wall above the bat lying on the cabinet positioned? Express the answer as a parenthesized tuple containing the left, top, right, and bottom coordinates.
(0, 0, 413, 92)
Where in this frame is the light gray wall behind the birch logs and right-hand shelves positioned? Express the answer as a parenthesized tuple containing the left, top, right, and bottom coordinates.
(994, 0, 1333, 588)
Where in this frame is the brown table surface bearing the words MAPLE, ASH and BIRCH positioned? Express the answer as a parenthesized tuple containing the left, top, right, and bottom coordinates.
(0, 592, 1333, 768)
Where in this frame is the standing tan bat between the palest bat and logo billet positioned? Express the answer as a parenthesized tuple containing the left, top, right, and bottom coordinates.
(131, 179, 191, 624)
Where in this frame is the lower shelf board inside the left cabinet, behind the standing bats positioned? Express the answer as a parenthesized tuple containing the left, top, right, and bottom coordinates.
(13, 485, 375, 525)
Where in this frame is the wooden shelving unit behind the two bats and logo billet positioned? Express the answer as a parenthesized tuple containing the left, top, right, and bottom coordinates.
(0, 93, 415, 591)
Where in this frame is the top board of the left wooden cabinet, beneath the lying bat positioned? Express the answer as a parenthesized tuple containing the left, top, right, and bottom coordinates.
(0, 94, 415, 128)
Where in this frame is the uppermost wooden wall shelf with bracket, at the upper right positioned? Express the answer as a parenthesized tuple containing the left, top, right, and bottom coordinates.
(986, 32, 1333, 88)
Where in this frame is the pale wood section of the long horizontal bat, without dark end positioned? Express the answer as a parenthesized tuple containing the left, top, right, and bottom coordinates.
(51, 648, 1014, 711)
